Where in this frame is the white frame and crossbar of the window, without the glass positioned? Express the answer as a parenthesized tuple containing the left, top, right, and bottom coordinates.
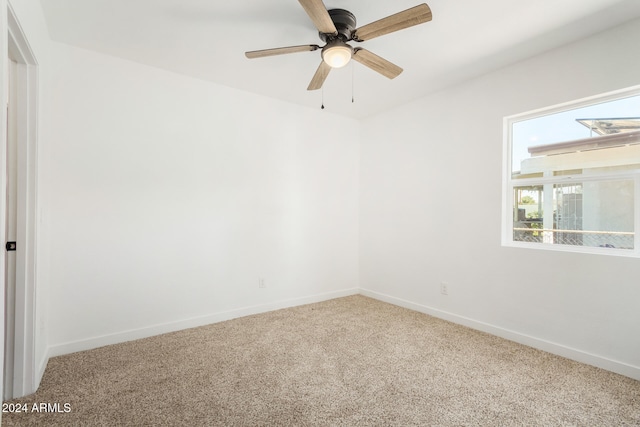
(502, 85, 640, 258)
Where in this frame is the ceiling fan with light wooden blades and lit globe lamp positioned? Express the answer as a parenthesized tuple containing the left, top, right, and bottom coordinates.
(245, 0, 431, 90)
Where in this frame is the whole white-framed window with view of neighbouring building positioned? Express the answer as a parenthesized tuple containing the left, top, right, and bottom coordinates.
(502, 87, 640, 256)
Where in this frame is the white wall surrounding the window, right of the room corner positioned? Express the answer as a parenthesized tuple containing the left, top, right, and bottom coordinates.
(360, 16, 640, 378)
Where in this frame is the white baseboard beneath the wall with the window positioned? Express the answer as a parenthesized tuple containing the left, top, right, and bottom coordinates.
(360, 289, 640, 380)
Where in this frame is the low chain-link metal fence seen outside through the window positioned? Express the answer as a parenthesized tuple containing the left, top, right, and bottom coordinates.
(513, 227, 635, 249)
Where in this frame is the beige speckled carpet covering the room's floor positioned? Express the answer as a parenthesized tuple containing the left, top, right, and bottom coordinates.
(2, 296, 640, 426)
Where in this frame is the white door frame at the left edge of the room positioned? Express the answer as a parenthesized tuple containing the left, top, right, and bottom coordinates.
(0, 0, 39, 398)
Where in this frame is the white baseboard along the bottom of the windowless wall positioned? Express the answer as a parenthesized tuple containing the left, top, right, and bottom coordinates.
(48, 288, 359, 360)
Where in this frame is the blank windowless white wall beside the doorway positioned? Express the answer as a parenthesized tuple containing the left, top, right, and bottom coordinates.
(43, 42, 359, 355)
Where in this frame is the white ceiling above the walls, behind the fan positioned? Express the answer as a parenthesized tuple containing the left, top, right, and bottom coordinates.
(41, 0, 640, 118)
